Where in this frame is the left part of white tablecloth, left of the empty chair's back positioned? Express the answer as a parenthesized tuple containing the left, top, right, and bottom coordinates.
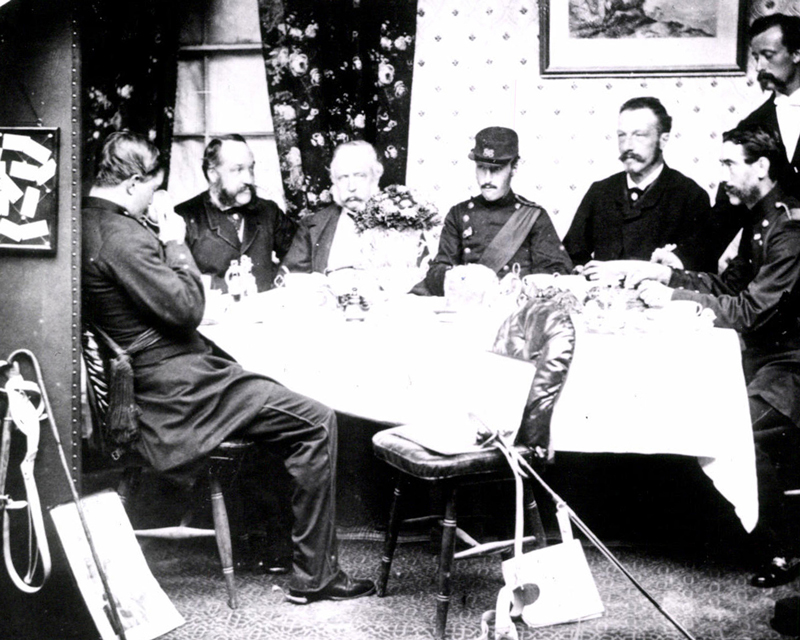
(201, 289, 534, 428)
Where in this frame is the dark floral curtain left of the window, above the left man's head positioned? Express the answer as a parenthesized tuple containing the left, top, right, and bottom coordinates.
(78, 0, 181, 188)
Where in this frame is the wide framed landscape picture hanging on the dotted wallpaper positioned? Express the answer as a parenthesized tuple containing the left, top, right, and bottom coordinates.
(539, 0, 747, 76)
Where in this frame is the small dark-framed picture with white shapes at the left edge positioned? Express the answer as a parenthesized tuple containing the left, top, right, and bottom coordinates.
(0, 127, 58, 255)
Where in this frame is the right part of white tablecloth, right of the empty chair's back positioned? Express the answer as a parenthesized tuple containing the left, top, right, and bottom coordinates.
(550, 325, 758, 531)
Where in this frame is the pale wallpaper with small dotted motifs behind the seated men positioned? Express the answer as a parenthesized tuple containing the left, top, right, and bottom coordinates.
(406, 0, 800, 236)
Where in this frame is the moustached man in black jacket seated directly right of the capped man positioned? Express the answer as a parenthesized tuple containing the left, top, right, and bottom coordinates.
(564, 97, 717, 271)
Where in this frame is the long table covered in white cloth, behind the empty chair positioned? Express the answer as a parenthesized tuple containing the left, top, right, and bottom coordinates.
(200, 288, 758, 531)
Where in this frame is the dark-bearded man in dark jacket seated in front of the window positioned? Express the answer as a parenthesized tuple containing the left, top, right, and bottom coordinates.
(175, 134, 296, 291)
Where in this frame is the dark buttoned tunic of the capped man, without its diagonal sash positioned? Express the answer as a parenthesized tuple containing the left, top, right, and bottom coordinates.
(425, 191, 572, 296)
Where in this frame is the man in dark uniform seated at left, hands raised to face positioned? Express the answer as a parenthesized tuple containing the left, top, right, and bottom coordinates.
(82, 132, 375, 603)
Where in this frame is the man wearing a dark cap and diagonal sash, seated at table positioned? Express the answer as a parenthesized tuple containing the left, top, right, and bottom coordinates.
(425, 127, 572, 296)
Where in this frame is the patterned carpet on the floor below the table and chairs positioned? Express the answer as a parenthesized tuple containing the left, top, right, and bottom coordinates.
(141, 541, 796, 640)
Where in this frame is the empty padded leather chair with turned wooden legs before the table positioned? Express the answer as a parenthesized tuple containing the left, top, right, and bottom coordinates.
(372, 299, 575, 638)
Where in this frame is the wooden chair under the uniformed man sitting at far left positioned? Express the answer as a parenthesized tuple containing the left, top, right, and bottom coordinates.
(82, 327, 254, 609)
